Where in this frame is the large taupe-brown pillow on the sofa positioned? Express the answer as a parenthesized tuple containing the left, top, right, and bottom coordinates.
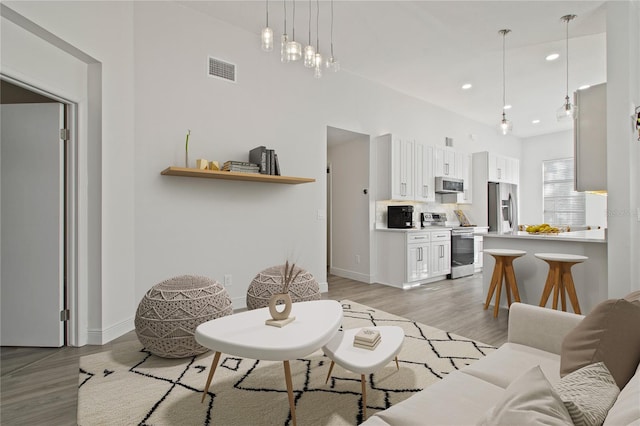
(560, 299, 640, 389)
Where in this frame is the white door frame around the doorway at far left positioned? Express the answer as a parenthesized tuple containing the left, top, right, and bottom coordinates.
(0, 72, 79, 346)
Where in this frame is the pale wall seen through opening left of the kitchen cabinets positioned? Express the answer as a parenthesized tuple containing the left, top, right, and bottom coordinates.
(327, 136, 371, 282)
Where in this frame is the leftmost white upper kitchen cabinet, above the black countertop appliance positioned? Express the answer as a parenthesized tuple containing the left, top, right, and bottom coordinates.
(375, 134, 414, 200)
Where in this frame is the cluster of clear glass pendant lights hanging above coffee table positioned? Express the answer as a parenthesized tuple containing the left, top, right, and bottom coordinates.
(262, 0, 340, 78)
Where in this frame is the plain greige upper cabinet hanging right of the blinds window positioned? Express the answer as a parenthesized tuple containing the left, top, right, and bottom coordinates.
(573, 83, 607, 191)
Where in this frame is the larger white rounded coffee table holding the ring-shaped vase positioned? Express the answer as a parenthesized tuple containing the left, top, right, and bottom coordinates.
(195, 300, 342, 426)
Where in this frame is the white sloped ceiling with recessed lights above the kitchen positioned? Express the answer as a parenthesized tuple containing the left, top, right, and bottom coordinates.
(182, 0, 606, 137)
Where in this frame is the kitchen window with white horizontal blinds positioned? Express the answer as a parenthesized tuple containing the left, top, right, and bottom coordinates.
(542, 158, 586, 225)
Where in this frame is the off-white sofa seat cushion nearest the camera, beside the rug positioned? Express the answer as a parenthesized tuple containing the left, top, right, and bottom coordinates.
(364, 371, 504, 426)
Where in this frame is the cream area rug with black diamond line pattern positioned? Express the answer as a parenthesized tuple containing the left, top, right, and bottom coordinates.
(78, 300, 496, 426)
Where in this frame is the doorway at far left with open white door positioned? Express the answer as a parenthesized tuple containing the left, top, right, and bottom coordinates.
(0, 75, 76, 347)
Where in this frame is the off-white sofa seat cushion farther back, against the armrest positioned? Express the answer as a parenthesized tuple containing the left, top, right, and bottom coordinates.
(461, 343, 560, 389)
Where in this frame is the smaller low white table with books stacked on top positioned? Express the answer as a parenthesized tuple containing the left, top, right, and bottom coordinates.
(322, 326, 404, 419)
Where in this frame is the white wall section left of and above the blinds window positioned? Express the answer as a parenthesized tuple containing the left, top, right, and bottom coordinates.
(518, 131, 573, 224)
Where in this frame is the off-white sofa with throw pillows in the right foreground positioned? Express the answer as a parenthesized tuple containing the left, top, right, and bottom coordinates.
(364, 303, 640, 426)
